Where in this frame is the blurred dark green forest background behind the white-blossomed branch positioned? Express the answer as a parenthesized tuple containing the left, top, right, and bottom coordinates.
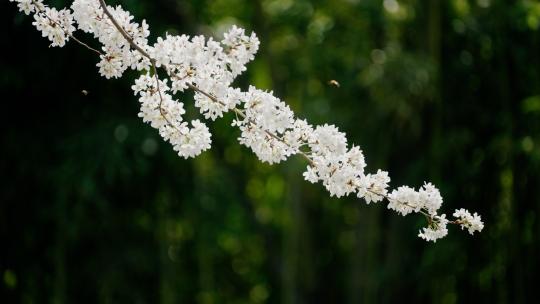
(0, 0, 540, 303)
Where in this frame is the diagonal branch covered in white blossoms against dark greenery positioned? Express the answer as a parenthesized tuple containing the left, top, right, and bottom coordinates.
(10, 0, 484, 241)
